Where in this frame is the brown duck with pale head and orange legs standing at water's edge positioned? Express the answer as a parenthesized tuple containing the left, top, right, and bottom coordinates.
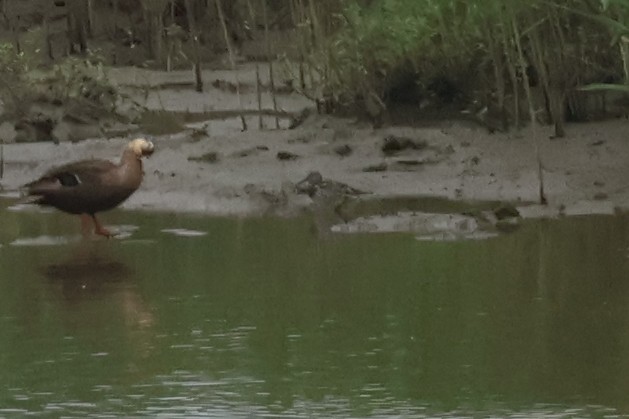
(24, 138, 155, 237)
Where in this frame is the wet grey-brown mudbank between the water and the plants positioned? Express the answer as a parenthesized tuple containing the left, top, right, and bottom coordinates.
(0, 67, 629, 236)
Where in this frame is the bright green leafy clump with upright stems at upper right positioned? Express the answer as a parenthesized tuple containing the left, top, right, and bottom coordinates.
(298, 0, 629, 136)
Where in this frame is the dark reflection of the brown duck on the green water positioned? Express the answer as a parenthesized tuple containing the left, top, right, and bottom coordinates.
(38, 240, 155, 362)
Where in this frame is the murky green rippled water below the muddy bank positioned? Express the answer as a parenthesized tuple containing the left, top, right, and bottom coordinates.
(0, 210, 629, 418)
